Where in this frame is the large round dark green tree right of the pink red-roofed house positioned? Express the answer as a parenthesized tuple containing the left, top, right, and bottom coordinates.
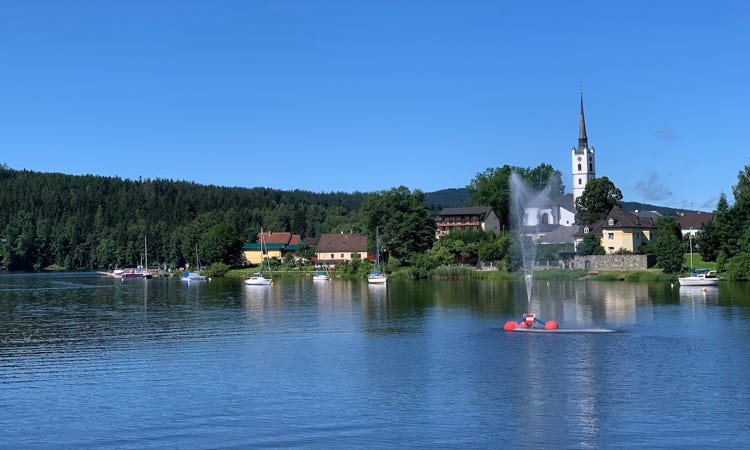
(361, 186, 436, 261)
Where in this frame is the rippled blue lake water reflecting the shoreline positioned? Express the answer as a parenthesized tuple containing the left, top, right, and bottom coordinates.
(0, 274, 750, 449)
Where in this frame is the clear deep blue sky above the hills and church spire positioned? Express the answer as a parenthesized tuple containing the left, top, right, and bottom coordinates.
(0, 0, 750, 211)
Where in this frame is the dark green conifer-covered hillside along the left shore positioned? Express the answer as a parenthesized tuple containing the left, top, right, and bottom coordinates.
(0, 166, 365, 270)
